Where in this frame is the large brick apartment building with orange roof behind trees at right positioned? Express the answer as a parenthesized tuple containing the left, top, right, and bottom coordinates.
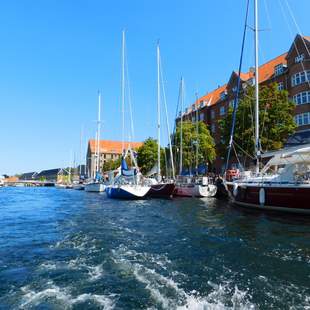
(176, 35, 310, 173)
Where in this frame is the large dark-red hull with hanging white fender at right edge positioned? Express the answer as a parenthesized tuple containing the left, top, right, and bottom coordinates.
(226, 182, 310, 214)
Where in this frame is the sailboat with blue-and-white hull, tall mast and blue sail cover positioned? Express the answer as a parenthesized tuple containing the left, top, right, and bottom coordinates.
(106, 31, 151, 199)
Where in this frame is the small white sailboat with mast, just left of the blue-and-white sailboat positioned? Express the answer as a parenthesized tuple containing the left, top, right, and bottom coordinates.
(84, 92, 105, 193)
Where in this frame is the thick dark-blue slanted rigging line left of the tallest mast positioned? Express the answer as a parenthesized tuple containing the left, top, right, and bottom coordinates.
(225, 0, 250, 171)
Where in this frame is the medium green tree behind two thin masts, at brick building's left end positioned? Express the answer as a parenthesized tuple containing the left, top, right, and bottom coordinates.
(174, 121, 216, 168)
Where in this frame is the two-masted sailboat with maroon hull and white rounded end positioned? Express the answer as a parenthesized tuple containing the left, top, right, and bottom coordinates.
(174, 78, 217, 197)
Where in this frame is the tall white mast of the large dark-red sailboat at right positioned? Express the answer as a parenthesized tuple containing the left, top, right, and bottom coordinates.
(254, 0, 260, 174)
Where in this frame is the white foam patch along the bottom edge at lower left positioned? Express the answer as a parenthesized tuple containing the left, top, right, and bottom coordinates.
(19, 282, 115, 310)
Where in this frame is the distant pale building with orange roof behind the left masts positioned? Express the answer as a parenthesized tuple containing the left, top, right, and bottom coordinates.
(86, 140, 143, 177)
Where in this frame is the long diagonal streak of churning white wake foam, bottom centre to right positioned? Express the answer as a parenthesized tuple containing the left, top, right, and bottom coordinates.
(112, 245, 255, 310)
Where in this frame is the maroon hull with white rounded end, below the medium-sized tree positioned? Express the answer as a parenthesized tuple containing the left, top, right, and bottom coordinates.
(174, 184, 217, 197)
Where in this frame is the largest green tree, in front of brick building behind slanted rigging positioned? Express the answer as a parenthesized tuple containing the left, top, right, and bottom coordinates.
(219, 83, 296, 158)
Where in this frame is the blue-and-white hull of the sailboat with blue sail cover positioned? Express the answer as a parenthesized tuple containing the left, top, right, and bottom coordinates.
(106, 185, 150, 200)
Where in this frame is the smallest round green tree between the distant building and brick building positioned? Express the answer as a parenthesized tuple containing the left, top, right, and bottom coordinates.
(137, 138, 165, 174)
